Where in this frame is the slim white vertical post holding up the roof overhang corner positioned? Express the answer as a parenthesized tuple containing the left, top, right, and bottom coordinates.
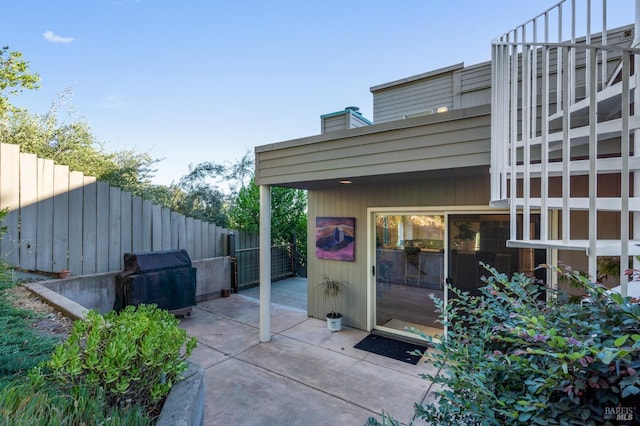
(260, 185, 271, 343)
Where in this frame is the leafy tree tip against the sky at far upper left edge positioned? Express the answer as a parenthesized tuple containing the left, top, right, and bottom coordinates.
(0, 46, 40, 118)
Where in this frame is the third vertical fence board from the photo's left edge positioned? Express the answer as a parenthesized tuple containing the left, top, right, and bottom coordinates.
(36, 158, 54, 271)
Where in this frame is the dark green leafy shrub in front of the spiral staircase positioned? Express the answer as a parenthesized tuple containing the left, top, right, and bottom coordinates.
(369, 266, 640, 425)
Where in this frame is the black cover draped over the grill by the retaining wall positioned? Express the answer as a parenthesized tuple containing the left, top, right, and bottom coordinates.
(113, 250, 196, 311)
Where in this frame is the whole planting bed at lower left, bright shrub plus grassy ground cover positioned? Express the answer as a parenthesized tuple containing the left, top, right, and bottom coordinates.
(0, 280, 196, 425)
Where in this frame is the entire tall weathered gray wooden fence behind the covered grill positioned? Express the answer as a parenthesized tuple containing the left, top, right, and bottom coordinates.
(0, 144, 231, 275)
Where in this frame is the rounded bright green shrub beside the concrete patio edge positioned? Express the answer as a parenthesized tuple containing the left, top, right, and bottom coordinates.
(30, 305, 197, 420)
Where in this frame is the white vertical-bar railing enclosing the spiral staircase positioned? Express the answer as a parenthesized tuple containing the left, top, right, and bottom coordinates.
(491, 0, 640, 292)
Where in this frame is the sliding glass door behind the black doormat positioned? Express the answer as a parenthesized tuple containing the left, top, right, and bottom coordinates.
(372, 212, 545, 338)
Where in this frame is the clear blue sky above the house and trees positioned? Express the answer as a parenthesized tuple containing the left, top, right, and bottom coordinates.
(0, 0, 633, 184)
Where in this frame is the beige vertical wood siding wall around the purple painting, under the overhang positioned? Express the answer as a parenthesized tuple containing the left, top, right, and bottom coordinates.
(307, 172, 490, 329)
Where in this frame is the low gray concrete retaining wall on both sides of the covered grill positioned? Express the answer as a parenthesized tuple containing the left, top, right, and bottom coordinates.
(38, 256, 231, 314)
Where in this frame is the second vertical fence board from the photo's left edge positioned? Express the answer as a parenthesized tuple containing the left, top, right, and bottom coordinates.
(20, 153, 38, 270)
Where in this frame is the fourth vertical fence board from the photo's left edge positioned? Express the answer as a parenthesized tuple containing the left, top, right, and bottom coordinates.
(52, 166, 70, 271)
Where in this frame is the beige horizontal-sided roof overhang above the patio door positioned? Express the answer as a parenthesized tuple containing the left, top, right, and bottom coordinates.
(255, 105, 491, 189)
